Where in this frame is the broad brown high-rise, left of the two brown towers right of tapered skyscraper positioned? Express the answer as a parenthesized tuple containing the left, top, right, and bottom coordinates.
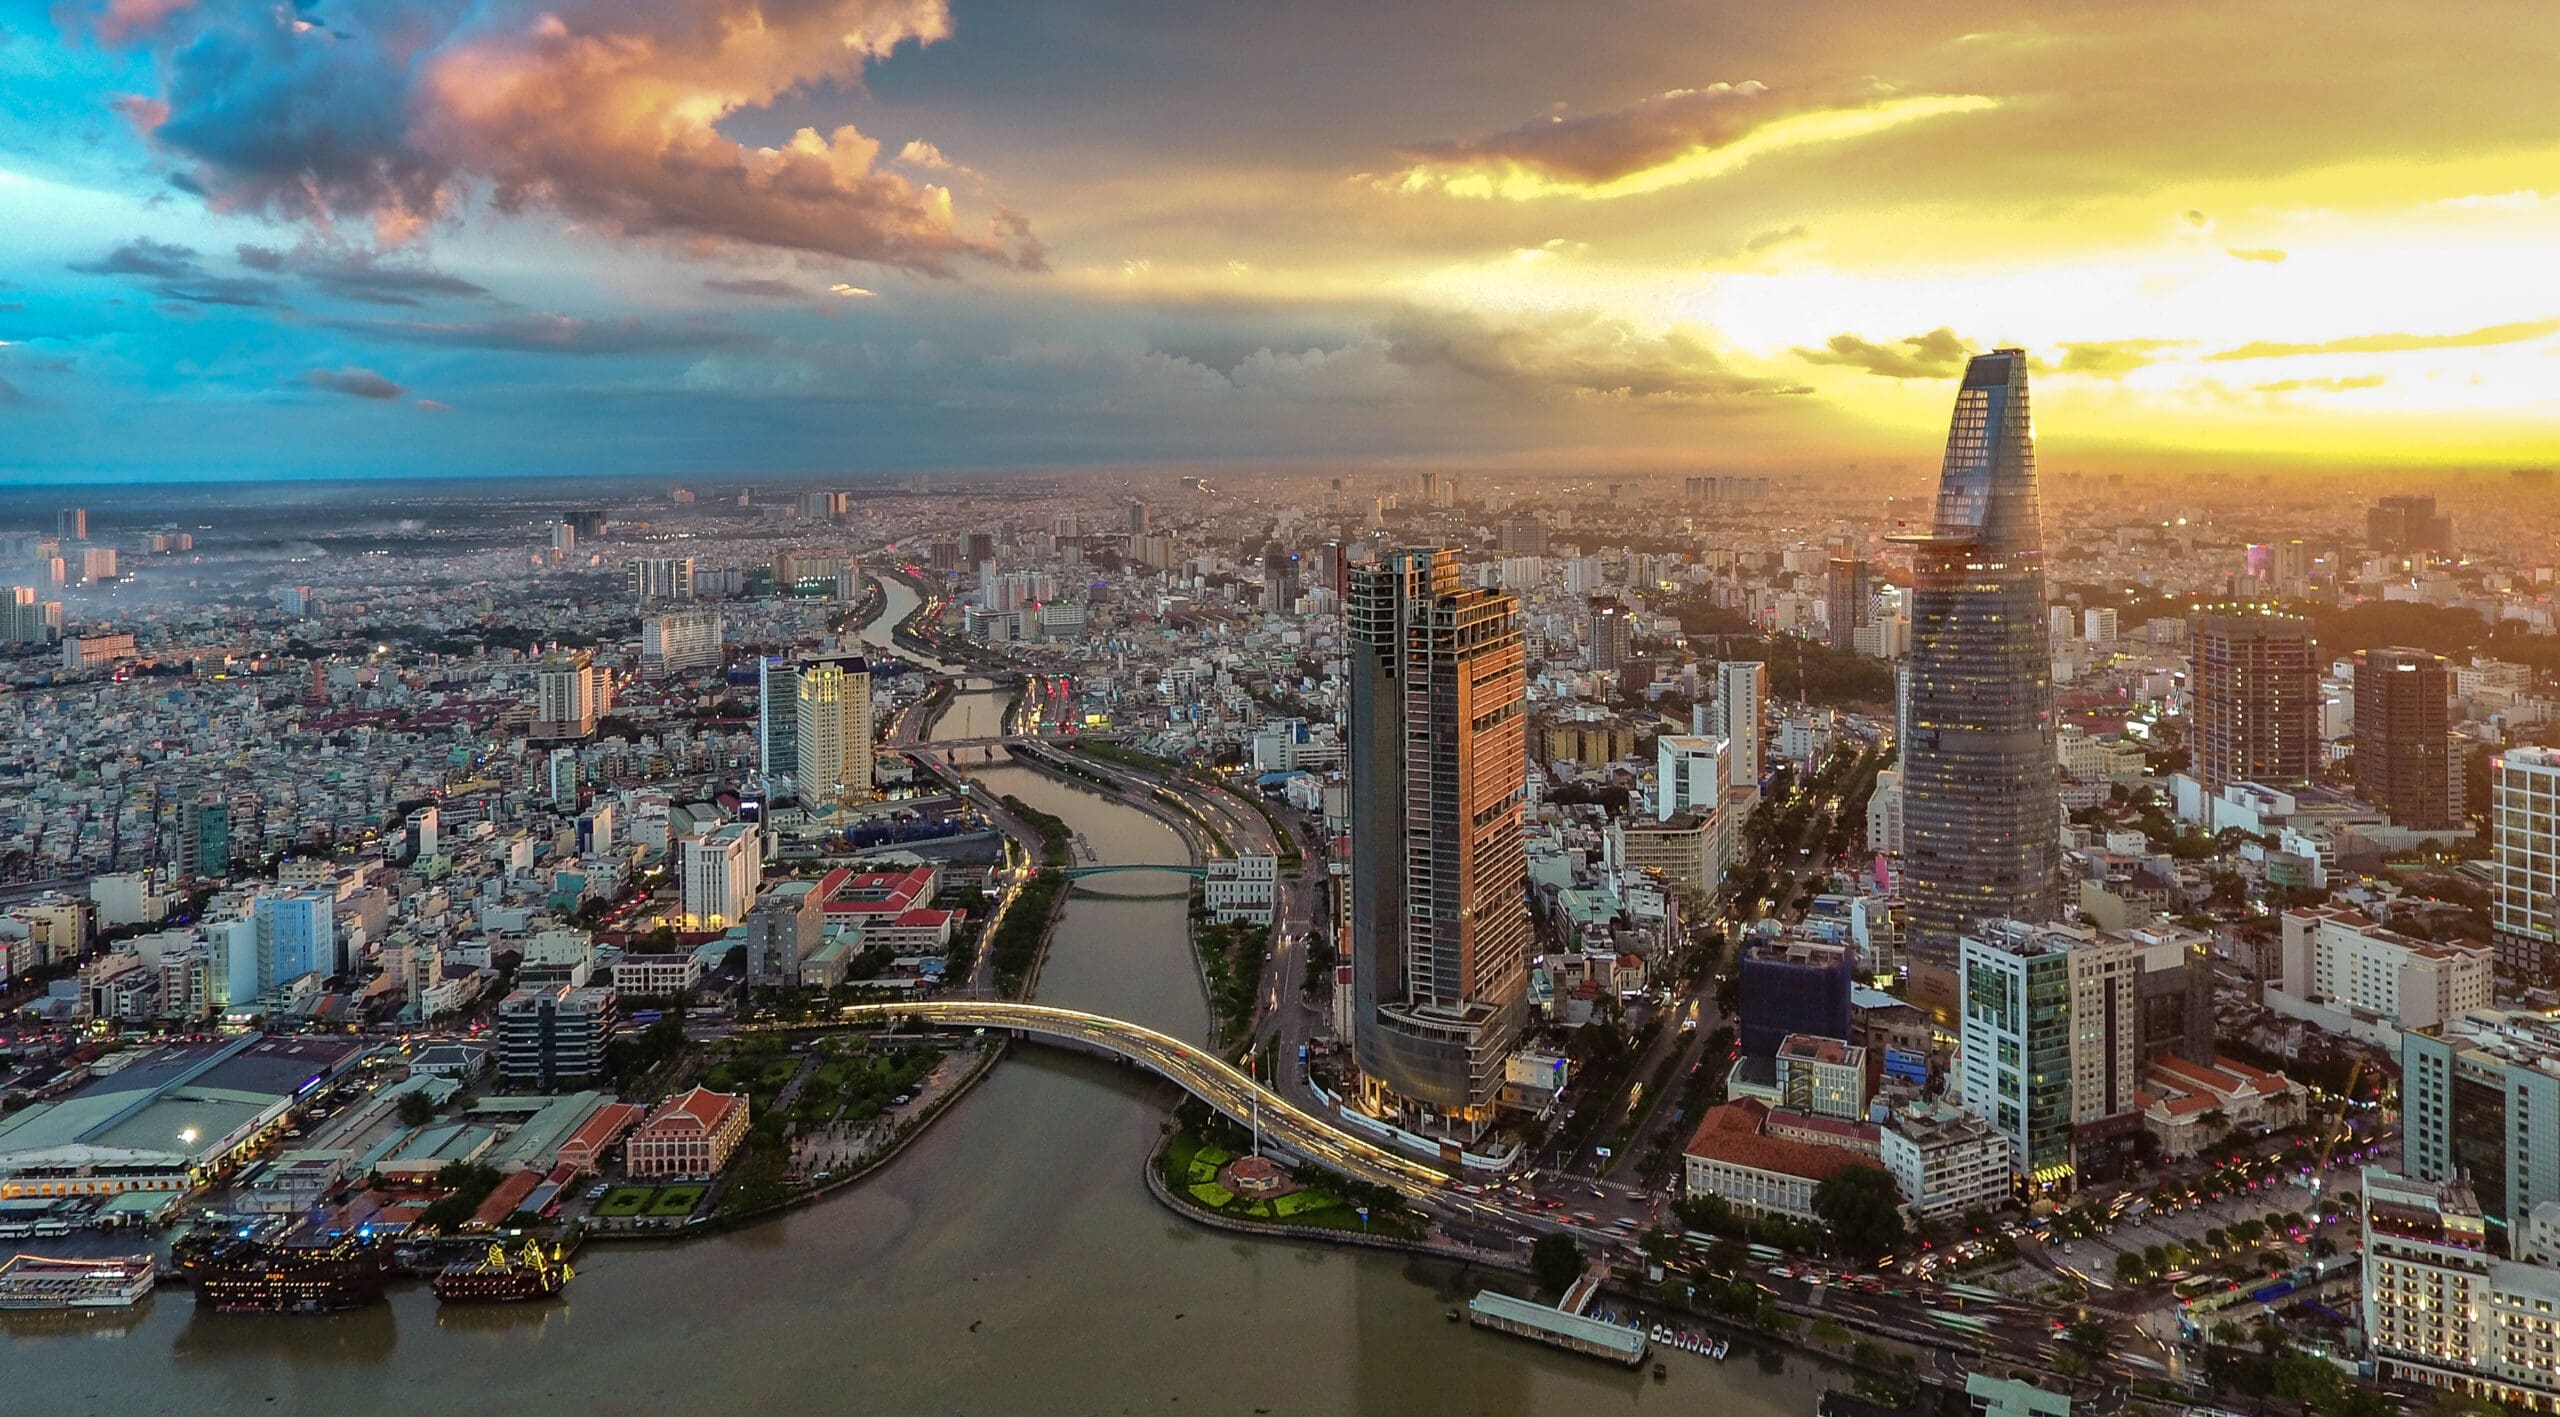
(2191, 609, 2322, 795)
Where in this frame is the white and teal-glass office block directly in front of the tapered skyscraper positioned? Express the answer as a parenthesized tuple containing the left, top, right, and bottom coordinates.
(1958, 921, 2143, 1189)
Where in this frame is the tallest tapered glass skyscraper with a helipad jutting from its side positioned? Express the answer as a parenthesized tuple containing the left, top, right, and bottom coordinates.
(1894, 348, 2061, 969)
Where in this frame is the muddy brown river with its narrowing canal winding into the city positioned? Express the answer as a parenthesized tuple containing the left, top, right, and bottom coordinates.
(0, 665, 1818, 1417)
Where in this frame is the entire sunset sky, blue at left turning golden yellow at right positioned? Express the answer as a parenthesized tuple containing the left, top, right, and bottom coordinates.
(0, 0, 2560, 483)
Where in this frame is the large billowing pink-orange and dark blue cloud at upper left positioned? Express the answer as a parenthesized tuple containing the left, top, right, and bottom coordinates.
(97, 0, 1042, 274)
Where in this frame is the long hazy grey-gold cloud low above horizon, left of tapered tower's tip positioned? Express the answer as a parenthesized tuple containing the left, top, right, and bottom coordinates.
(1382, 309, 1805, 399)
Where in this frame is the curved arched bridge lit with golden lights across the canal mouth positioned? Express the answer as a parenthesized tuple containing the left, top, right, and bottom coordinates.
(845, 1000, 1446, 1197)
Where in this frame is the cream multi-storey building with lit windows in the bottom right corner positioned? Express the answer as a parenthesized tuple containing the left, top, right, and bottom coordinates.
(2358, 1166, 2560, 1412)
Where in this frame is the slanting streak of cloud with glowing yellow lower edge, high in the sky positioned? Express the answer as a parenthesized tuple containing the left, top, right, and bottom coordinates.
(1375, 82, 1999, 202)
